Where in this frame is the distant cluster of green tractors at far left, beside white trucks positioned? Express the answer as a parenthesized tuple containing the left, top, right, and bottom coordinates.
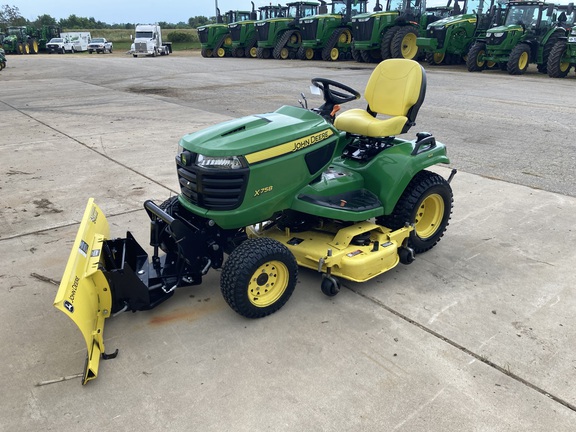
(0, 25, 61, 54)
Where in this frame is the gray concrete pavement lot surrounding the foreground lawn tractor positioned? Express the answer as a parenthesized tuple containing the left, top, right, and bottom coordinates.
(0, 53, 576, 431)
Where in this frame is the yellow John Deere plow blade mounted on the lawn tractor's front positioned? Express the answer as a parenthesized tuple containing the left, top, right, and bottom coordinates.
(54, 198, 116, 385)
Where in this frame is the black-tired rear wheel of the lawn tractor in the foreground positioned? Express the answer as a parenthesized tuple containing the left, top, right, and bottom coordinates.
(377, 171, 453, 253)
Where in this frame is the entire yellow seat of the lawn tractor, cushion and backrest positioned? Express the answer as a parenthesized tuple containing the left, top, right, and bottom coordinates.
(334, 59, 426, 138)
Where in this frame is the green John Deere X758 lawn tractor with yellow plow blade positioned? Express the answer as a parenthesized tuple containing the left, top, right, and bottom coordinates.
(54, 59, 456, 384)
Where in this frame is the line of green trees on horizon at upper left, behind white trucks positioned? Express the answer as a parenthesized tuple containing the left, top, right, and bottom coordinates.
(0, 5, 216, 31)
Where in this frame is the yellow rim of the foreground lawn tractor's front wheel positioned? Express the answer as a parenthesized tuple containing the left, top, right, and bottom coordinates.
(248, 261, 289, 308)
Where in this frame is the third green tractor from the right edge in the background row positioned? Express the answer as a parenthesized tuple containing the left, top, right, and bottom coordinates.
(416, 0, 502, 65)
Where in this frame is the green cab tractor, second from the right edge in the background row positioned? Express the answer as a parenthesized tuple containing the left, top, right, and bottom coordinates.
(466, 1, 567, 75)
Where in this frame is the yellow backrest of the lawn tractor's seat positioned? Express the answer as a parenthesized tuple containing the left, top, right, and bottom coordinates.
(364, 59, 426, 123)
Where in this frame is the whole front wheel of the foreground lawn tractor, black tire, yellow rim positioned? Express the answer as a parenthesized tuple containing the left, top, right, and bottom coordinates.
(220, 238, 298, 318)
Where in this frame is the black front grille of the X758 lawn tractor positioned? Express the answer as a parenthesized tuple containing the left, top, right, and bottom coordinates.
(176, 157, 249, 210)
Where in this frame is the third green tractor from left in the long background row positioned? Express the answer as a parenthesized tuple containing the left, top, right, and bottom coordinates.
(256, 1, 319, 60)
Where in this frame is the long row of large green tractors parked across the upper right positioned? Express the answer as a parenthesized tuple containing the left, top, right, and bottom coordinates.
(198, 0, 576, 77)
